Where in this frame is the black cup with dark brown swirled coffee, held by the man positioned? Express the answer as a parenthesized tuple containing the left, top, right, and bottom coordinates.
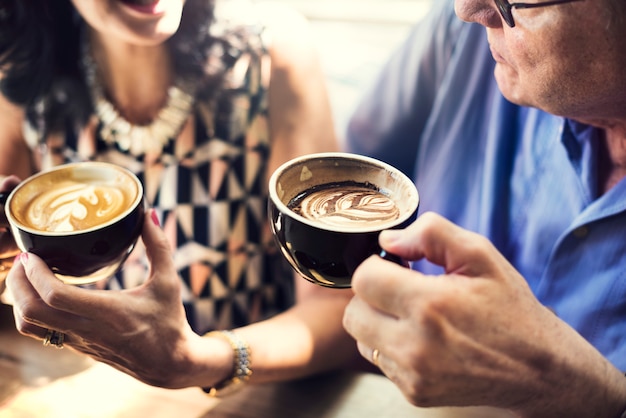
(268, 153, 419, 288)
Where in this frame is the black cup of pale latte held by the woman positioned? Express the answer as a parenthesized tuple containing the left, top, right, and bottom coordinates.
(5, 162, 145, 284)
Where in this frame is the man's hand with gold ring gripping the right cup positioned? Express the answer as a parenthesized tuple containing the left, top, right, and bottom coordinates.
(344, 213, 626, 417)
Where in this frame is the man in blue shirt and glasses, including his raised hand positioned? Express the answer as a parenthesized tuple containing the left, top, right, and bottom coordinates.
(344, 0, 626, 417)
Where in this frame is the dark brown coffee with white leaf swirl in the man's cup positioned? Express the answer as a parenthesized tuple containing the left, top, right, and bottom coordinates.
(287, 181, 400, 230)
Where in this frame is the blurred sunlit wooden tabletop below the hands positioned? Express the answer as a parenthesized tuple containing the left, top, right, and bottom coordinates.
(0, 304, 511, 418)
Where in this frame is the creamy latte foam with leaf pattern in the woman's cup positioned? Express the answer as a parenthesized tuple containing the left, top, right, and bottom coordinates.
(25, 180, 130, 232)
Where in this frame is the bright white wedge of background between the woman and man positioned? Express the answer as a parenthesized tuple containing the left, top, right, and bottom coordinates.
(256, 0, 433, 138)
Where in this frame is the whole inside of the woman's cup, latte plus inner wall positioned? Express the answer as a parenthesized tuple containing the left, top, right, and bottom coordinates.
(11, 165, 139, 232)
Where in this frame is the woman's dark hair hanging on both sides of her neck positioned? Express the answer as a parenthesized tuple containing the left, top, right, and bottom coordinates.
(0, 0, 215, 132)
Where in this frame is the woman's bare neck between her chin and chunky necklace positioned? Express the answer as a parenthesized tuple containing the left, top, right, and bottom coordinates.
(90, 31, 174, 124)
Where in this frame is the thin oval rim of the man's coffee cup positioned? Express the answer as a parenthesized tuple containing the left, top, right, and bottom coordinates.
(268, 151, 420, 234)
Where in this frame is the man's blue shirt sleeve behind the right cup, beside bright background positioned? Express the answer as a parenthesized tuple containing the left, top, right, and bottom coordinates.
(346, 0, 462, 175)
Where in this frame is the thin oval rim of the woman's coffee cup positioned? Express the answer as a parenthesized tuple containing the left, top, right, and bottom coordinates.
(4, 161, 144, 237)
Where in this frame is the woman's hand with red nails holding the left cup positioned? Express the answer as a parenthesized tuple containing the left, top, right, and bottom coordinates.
(7, 212, 232, 388)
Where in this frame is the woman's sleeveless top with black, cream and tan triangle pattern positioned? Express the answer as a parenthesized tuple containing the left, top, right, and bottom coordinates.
(20, 7, 293, 333)
